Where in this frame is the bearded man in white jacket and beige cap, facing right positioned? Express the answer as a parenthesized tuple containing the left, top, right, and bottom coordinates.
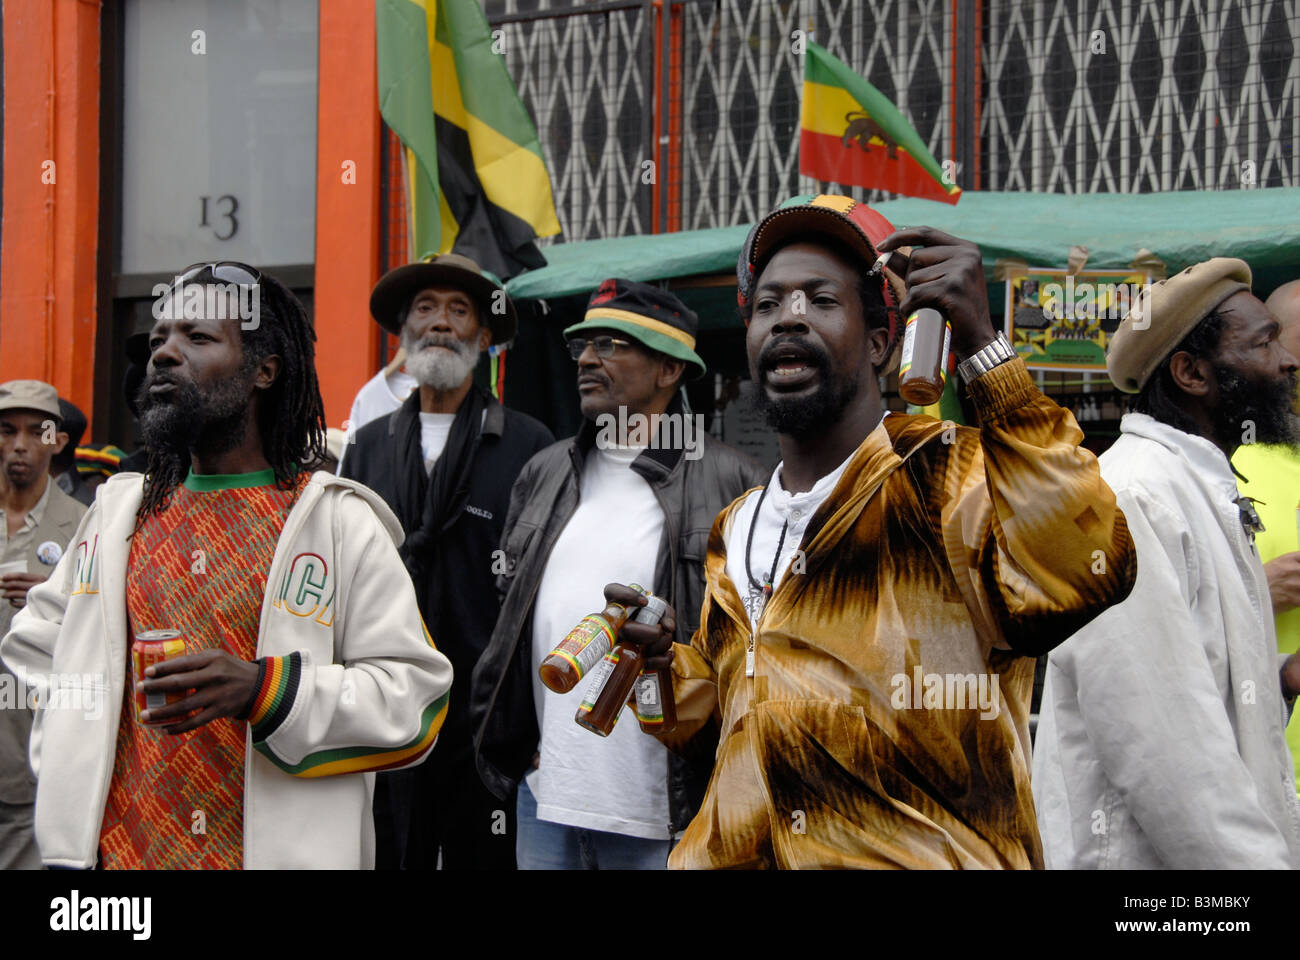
(1034, 258, 1300, 869)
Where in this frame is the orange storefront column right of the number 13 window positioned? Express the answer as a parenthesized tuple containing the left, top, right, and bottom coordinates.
(315, 0, 382, 427)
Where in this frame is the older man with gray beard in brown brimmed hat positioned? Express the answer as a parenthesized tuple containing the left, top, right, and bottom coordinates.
(339, 254, 554, 869)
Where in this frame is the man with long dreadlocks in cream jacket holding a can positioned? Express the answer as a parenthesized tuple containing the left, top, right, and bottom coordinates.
(0, 263, 451, 868)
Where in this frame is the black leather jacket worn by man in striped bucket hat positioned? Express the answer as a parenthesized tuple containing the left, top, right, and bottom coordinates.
(471, 399, 767, 833)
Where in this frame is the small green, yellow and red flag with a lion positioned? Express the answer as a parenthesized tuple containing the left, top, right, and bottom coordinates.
(800, 43, 962, 203)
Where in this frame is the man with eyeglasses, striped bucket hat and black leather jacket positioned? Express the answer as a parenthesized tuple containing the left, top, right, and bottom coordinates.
(472, 280, 763, 869)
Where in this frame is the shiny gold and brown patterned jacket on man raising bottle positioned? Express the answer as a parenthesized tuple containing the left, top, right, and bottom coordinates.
(662, 359, 1136, 868)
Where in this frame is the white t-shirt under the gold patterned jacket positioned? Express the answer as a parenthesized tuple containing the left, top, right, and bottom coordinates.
(727, 414, 888, 627)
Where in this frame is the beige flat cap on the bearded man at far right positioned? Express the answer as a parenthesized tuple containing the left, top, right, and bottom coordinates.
(1106, 256, 1251, 393)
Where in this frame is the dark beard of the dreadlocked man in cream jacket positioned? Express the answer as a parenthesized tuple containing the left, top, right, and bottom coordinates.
(135, 369, 252, 460)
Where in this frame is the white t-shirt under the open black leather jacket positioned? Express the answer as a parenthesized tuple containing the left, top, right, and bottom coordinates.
(527, 447, 670, 840)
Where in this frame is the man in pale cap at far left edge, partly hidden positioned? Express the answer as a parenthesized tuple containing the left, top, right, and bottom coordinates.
(0, 380, 86, 870)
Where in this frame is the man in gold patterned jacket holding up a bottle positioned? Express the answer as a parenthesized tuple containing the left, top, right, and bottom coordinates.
(606, 196, 1136, 868)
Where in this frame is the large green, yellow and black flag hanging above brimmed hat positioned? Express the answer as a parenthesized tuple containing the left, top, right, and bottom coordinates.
(374, 0, 560, 280)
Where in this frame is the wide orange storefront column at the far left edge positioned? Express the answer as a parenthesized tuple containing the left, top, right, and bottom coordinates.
(0, 0, 100, 418)
